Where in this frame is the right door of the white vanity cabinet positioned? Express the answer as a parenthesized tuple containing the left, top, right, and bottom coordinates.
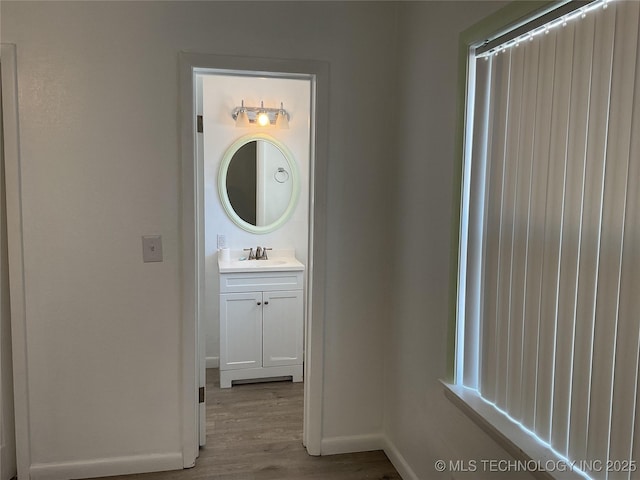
(262, 290, 304, 367)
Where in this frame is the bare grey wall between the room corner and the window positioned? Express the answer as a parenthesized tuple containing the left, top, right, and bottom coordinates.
(384, 2, 531, 480)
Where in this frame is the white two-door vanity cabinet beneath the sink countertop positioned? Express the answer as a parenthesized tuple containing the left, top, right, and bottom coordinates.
(220, 271, 304, 388)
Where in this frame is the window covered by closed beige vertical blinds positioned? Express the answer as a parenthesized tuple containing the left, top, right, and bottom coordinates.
(456, 0, 640, 479)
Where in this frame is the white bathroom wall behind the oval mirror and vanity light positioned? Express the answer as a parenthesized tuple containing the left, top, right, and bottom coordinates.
(202, 74, 311, 367)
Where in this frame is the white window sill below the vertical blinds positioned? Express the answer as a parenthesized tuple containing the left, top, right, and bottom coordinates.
(442, 381, 590, 480)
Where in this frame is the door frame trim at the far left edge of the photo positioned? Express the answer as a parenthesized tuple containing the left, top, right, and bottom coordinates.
(0, 43, 31, 478)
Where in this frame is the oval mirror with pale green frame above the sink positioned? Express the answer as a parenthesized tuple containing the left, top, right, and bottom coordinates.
(218, 133, 300, 233)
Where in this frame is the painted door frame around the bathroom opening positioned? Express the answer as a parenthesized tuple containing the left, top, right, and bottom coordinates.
(179, 52, 329, 467)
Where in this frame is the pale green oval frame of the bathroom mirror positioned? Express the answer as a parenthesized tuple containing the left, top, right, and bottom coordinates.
(218, 133, 300, 234)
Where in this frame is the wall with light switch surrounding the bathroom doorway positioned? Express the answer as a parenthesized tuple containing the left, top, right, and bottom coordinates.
(0, 1, 396, 472)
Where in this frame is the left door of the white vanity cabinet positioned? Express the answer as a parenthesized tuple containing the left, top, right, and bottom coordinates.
(220, 292, 262, 370)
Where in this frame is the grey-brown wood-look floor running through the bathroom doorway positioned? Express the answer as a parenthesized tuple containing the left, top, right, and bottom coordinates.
(98, 369, 401, 480)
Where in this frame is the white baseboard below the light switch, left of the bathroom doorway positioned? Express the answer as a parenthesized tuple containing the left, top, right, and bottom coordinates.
(29, 453, 183, 480)
